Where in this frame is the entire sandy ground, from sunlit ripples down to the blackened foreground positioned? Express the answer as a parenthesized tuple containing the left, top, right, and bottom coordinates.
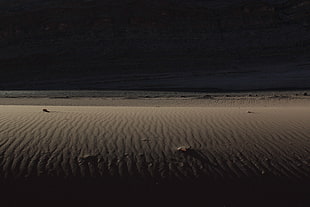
(0, 98, 310, 206)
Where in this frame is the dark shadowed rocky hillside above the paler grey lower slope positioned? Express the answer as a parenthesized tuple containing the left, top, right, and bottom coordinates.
(0, 0, 310, 89)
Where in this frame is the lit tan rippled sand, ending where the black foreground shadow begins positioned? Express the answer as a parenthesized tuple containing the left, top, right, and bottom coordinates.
(0, 98, 310, 206)
